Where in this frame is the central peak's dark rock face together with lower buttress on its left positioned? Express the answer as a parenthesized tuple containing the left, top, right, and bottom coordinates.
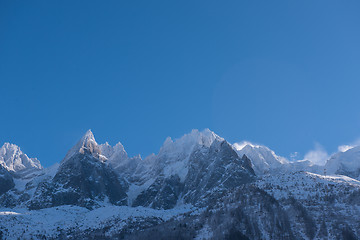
(134, 139, 255, 209)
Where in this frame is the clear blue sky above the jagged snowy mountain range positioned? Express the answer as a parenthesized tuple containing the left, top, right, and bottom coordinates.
(0, 0, 360, 166)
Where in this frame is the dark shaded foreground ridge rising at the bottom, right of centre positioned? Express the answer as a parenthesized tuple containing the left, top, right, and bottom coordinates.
(124, 184, 296, 240)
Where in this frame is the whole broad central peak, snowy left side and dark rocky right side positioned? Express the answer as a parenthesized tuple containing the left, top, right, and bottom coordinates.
(130, 129, 254, 209)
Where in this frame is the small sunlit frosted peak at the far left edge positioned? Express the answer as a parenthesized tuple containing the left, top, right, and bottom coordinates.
(0, 143, 42, 172)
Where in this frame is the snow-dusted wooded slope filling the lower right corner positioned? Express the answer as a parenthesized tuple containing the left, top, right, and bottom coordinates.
(256, 172, 360, 239)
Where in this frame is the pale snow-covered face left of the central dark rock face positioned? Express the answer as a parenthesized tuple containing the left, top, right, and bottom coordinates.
(125, 129, 223, 205)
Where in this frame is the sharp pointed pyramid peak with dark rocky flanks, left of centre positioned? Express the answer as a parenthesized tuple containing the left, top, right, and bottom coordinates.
(29, 129, 128, 209)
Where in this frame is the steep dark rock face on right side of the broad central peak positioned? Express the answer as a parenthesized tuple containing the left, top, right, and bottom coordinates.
(184, 141, 255, 204)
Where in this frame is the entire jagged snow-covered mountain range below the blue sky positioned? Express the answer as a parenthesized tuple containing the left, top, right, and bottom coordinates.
(0, 129, 360, 239)
